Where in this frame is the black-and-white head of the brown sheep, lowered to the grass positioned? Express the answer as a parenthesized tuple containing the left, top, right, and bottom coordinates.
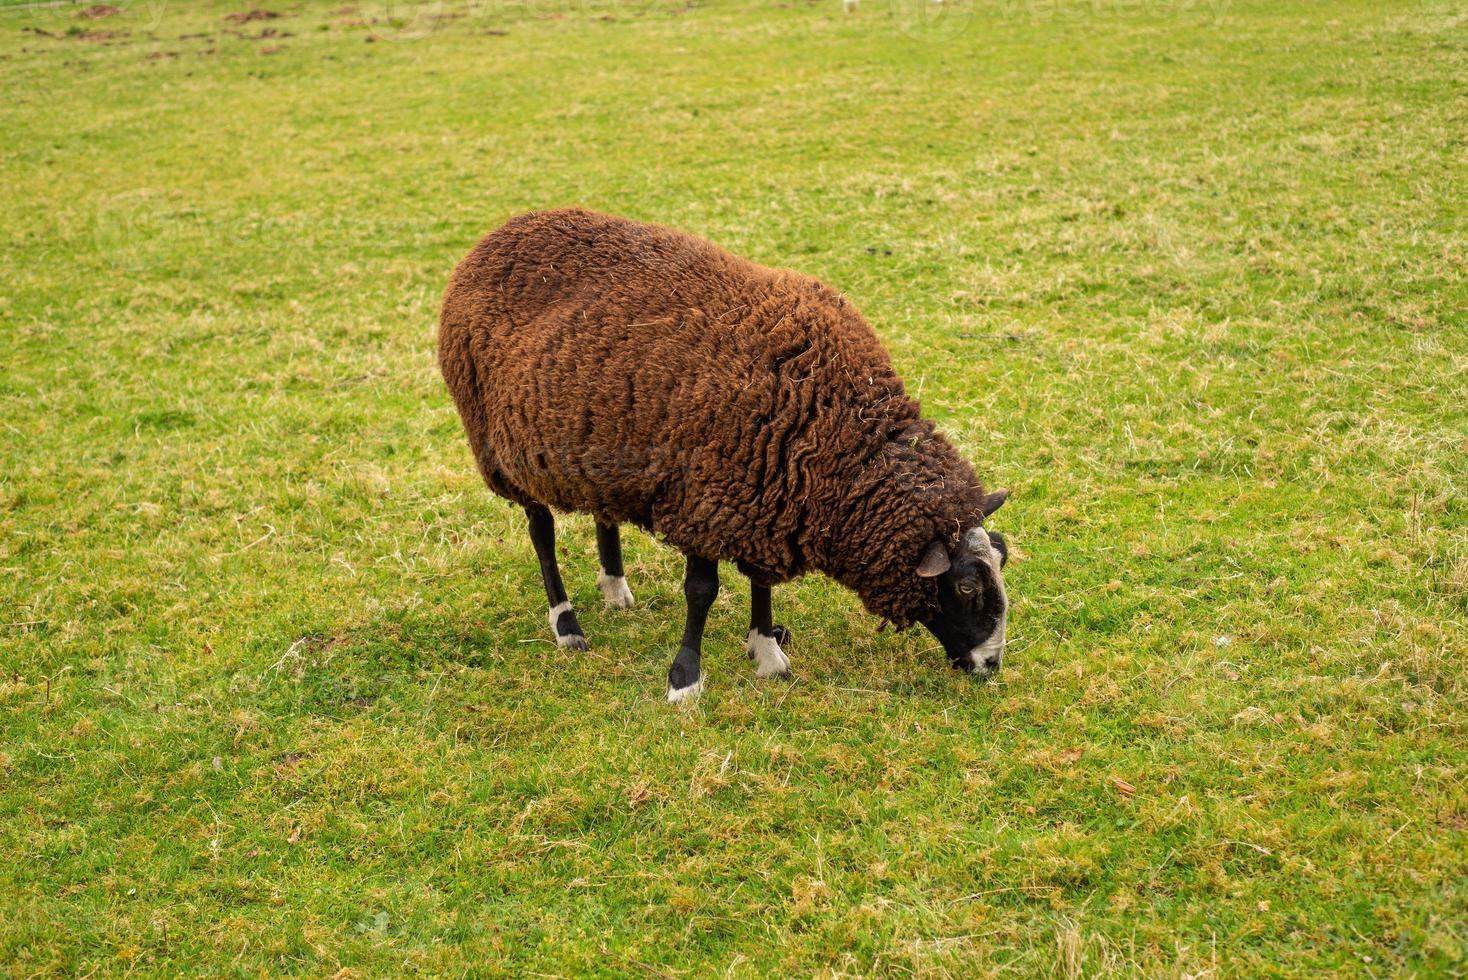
(918, 494, 1009, 675)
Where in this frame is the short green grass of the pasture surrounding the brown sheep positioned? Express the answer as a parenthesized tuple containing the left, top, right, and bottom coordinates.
(0, 0, 1468, 977)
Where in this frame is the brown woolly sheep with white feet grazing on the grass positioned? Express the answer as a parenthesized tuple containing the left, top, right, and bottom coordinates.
(439, 208, 1009, 701)
